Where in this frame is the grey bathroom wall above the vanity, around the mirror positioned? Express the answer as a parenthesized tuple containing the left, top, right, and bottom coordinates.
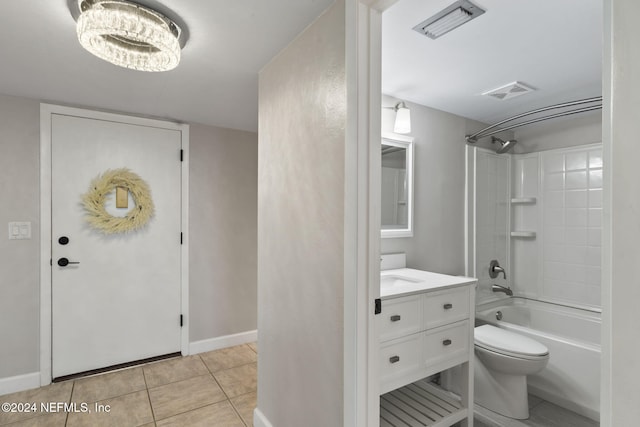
(381, 95, 511, 275)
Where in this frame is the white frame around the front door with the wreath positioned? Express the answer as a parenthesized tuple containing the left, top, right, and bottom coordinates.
(40, 103, 189, 386)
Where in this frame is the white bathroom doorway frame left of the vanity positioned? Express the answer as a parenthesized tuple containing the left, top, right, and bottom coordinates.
(343, 0, 398, 427)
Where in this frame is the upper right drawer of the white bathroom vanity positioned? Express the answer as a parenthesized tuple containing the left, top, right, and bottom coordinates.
(424, 287, 469, 329)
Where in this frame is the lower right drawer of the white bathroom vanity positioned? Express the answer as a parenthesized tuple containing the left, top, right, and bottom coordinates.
(424, 320, 469, 366)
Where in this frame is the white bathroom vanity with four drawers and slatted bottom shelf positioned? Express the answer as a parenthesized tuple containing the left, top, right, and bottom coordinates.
(378, 268, 477, 427)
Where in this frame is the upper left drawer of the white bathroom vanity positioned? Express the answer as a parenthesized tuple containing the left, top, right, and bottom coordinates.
(377, 295, 422, 341)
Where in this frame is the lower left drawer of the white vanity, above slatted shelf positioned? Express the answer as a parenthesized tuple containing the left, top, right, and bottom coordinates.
(380, 334, 424, 393)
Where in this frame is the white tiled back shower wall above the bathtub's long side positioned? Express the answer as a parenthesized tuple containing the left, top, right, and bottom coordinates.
(511, 144, 602, 307)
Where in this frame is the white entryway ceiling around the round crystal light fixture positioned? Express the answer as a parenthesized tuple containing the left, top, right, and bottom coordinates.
(0, 0, 332, 131)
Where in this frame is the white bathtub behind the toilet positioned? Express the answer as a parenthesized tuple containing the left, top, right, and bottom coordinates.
(476, 297, 601, 421)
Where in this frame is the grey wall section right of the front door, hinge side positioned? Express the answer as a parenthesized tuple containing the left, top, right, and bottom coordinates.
(189, 125, 258, 342)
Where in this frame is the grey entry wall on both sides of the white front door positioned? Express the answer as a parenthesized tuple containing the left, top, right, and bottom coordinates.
(0, 95, 258, 381)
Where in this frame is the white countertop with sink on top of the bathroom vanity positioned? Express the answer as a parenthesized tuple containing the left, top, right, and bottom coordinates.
(380, 268, 478, 299)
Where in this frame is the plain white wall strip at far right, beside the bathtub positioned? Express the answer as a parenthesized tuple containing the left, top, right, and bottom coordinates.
(601, 0, 640, 427)
